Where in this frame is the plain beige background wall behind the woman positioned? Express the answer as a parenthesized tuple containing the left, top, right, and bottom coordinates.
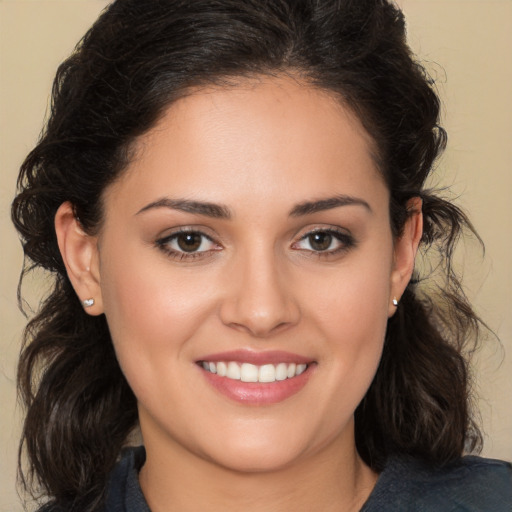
(0, 0, 512, 512)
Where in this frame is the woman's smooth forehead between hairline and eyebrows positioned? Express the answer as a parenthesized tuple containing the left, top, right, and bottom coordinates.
(107, 77, 384, 217)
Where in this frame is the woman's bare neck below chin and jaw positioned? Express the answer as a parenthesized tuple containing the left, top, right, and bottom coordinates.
(139, 420, 377, 512)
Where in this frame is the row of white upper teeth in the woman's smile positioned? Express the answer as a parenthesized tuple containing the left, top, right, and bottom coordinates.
(201, 361, 308, 382)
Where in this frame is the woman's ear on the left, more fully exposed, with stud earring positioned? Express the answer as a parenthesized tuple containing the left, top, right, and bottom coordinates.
(55, 201, 103, 315)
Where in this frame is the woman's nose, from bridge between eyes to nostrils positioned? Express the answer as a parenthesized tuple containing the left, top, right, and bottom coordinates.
(220, 250, 300, 338)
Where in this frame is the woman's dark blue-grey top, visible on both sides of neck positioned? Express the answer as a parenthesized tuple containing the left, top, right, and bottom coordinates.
(44, 447, 512, 512)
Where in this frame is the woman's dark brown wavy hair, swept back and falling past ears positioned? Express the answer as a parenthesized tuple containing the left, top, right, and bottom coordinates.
(12, 0, 481, 512)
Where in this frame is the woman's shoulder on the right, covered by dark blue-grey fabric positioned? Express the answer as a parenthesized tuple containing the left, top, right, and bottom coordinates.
(363, 456, 512, 512)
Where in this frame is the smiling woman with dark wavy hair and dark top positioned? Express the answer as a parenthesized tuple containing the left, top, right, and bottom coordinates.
(13, 0, 512, 512)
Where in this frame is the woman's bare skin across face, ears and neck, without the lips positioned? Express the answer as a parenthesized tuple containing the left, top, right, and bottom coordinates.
(56, 77, 421, 512)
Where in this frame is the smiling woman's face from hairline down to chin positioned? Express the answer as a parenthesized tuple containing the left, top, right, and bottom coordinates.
(82, 78, 416, 471)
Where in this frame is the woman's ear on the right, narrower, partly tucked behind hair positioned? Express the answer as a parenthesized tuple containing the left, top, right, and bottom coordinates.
(388, 197, 423, 317)
